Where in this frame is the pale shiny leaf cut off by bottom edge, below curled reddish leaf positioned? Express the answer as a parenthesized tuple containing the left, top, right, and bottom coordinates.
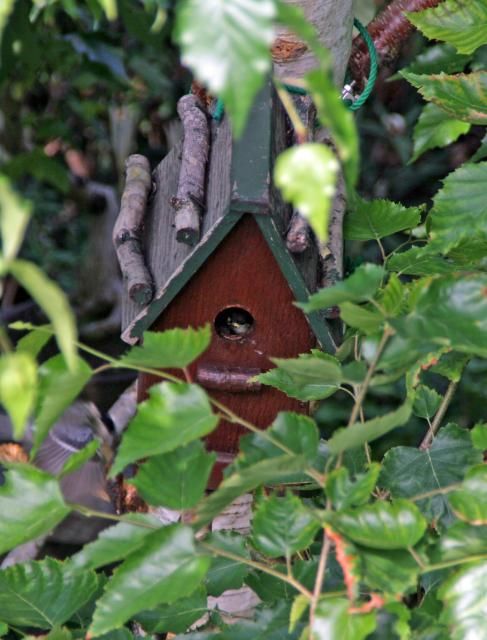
(312, 598, 377, 640)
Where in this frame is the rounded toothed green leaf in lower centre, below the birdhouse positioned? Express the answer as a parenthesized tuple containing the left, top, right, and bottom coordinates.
(252, 492, 320, 558)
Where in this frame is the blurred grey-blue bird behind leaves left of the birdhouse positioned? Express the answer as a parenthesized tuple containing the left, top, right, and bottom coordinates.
(0, 401, 115, 545)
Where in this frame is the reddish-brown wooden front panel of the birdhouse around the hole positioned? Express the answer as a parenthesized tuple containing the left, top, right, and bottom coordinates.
(139, 215, 315, 484)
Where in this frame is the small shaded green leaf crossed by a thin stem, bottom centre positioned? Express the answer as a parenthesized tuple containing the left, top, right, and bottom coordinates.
(205, 531, 250, 596)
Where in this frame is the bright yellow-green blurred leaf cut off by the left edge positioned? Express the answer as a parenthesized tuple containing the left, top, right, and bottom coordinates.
(0, 353, 37, 440)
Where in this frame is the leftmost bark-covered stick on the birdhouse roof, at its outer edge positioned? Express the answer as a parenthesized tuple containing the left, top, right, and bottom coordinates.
(113, 154, 153, 305)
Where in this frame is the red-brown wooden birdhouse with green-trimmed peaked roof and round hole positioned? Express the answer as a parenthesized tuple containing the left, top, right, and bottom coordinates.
(118, 86, 333, 487)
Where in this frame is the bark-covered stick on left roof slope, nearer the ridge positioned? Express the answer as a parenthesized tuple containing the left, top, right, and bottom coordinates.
(171, 94, 210, 246)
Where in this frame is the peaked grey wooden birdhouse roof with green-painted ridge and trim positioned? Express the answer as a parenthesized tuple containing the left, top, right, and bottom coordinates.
(122, 84, 335, 351)
